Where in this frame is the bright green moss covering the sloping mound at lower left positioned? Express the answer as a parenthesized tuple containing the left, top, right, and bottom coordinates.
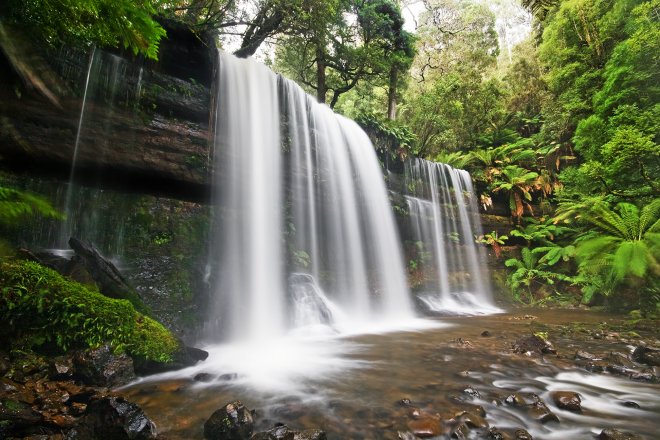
(0, 261, 180, 362)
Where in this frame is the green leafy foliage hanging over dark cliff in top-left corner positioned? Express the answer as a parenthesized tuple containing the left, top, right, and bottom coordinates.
(4, 0, 165, 59)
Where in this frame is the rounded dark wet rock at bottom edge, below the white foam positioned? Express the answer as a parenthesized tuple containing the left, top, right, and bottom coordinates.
(204, 400, 254, 440)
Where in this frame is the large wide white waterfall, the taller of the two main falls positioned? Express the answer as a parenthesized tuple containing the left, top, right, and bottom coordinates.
(207, 53, 413, 341)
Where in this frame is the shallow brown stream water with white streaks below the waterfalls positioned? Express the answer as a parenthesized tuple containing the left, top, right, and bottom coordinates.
(123, 310, 660, 439)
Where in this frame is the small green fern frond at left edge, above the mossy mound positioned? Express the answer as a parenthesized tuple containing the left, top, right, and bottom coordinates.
(0, 186, 63, 226)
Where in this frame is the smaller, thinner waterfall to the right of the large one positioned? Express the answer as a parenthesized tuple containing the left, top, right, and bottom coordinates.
(405, 159, 499, 314)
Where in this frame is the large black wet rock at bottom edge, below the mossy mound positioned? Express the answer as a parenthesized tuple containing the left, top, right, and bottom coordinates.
(74, 397, 156, 440)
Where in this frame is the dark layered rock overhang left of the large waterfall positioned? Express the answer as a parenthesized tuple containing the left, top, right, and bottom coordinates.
(0, 23, 215, 201)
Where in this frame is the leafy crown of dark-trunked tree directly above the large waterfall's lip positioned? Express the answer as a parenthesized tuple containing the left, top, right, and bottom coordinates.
(274, 0, 413, 108)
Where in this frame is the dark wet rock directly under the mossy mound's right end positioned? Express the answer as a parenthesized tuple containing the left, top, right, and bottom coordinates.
(73, 345, 135, 388)
